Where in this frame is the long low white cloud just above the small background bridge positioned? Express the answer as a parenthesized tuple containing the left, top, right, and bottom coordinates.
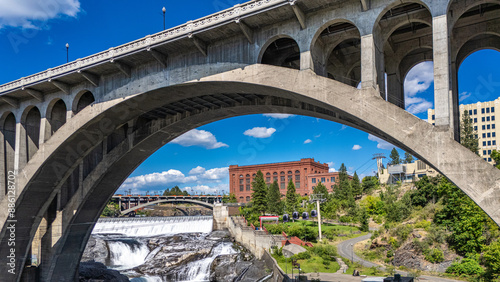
(120, 169, 197, 189)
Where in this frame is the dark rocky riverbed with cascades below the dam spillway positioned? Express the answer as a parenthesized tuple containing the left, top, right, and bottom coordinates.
(80, 231, 270, 281)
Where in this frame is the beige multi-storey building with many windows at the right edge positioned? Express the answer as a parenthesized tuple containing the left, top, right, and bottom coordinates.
(427, 98, 500, 164)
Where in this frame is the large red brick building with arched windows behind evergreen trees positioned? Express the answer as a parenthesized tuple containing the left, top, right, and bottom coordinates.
(229, 158, 344, 203)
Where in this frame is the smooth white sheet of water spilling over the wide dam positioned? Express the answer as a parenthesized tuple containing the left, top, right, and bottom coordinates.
(92, 216, 213, 237)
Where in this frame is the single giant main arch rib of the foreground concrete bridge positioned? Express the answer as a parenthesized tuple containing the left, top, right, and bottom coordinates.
(0, 64, 500, 281)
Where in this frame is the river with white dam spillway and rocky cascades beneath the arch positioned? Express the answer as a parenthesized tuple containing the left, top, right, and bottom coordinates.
(82, 216, 253, 282)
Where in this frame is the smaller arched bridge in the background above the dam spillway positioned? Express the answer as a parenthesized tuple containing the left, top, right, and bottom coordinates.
(111, 195, 222, 215)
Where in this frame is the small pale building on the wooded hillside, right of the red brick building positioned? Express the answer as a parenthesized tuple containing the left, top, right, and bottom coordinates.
(379, 160, 439, 184)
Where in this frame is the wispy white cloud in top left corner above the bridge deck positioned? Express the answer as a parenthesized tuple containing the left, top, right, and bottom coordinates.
(0, 0, 80, 29)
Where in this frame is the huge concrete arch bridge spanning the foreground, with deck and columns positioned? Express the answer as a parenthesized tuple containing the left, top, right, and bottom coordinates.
(0, 0, 500, 281)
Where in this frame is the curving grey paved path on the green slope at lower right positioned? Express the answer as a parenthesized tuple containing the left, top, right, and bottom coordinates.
(336, 234, 459, 282)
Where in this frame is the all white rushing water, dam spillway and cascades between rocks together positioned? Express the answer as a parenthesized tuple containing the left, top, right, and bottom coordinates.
(88, 216, 237, 282)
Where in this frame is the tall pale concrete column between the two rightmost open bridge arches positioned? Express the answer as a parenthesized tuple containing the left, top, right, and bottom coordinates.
(432, 15, 455, 137)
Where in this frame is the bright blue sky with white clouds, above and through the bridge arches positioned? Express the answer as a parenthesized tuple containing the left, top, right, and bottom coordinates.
(0, 0, 500, 193)
